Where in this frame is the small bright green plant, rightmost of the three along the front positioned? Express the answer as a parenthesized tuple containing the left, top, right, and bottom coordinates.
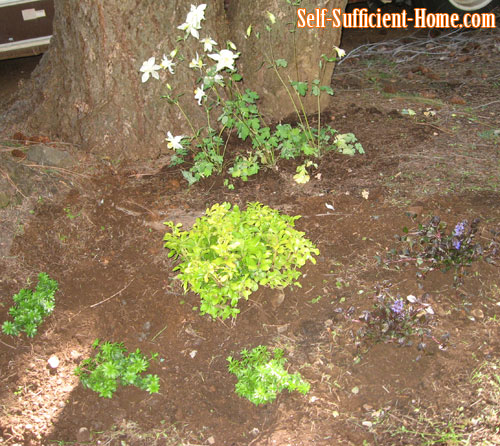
(227, 345, 311, 406)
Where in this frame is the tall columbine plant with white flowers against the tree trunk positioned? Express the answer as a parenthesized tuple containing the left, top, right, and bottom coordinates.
(140, 4, 364, 187)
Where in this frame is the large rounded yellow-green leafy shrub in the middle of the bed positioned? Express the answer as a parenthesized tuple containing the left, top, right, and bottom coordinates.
(164, 203, 319, 319)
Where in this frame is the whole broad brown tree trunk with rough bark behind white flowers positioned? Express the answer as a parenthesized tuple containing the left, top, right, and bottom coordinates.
(2, 0, 345, 159)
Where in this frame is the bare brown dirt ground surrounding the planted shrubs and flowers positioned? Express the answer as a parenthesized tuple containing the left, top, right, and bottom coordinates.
(0, 15, 500, 446)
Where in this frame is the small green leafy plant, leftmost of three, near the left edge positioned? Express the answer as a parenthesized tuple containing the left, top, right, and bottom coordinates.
(2, 273, 58, 338)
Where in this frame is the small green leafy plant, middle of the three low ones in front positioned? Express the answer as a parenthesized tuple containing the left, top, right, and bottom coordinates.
(75, 339, 160, 398)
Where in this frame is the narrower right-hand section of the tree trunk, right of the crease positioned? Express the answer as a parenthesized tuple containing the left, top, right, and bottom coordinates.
(228, 0, 347, 121)
